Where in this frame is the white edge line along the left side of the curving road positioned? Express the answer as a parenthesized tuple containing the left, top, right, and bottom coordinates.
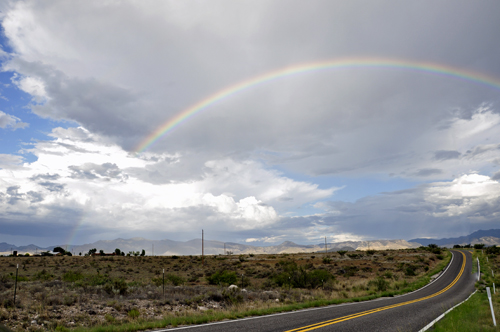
(153, 251, 455, 332)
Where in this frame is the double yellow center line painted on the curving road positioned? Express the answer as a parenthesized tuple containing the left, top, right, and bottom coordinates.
(285, 252, 467, 332)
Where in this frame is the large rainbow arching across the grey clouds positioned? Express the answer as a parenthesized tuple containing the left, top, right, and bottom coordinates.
(134, 58, 500, 152)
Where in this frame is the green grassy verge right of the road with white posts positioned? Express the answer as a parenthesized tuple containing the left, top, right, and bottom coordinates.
(430, 245, 500, 332)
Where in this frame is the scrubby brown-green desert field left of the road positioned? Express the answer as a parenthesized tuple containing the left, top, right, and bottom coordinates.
(0, 246, 451, 332)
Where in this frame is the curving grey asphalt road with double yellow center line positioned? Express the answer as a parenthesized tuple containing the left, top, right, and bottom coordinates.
(157, 250, 477, 332)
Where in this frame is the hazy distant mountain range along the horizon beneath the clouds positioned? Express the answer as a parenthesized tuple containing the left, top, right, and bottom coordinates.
(0, 229, 500, 255)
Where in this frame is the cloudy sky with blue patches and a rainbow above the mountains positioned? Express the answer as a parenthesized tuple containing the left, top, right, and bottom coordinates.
(0, 0, 500, 246)
